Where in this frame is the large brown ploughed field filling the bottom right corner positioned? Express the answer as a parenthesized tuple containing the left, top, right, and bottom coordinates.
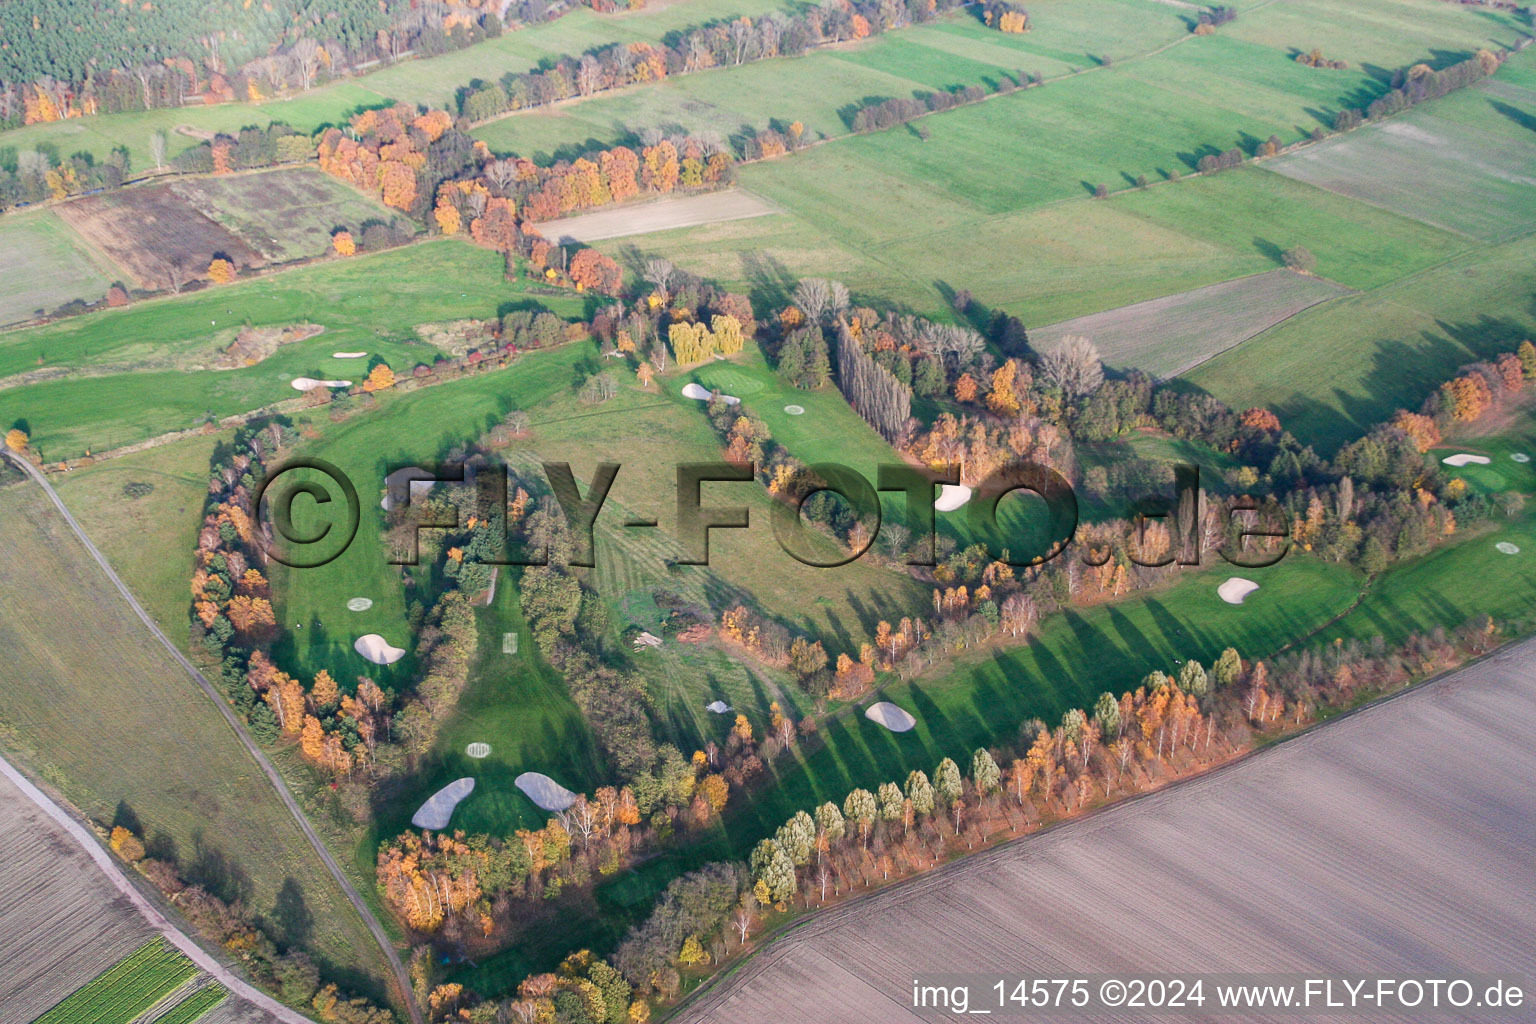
(677, 640, 1536, 1024)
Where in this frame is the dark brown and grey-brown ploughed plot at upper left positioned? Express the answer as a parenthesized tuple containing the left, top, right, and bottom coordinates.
(55, 167, 412, 290)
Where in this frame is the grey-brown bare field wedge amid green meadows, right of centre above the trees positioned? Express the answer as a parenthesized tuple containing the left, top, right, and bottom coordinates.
(1029, 270, 1349, 378)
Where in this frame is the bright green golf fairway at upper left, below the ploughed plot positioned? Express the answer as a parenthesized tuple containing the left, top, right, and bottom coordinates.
(0, 239, 585, 459)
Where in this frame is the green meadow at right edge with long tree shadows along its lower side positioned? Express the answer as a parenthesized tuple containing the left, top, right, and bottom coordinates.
(1189, 236, 1536, 451)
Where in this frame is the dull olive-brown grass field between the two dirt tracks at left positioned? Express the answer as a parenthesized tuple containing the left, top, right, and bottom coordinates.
(0, 484, 382, 990)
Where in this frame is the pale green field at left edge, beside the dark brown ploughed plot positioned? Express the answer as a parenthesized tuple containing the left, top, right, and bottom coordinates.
(0, 210, 118, 325)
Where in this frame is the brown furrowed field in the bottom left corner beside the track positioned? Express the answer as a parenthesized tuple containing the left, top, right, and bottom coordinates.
(0, 767, 154, 1024)
